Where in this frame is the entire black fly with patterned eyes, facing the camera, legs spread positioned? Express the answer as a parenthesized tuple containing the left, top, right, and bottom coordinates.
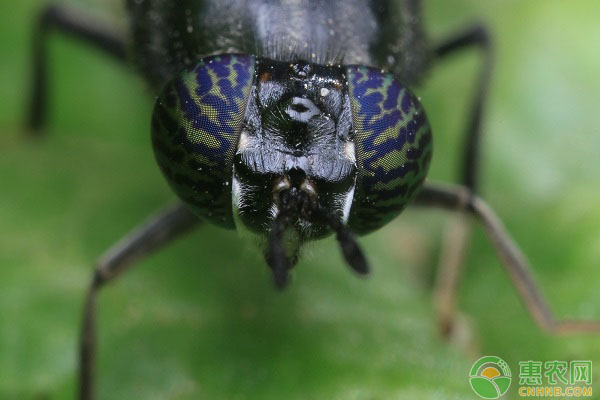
(24, 0, 600, 399)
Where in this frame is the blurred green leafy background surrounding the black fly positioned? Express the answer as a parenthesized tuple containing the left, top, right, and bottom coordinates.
(0, 0, 600, 400)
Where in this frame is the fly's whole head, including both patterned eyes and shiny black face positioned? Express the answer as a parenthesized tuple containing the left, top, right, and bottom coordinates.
(153, 54, 431, 268)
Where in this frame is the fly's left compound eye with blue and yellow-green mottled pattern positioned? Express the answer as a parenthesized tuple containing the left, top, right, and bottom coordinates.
(152, 54, 255, 228)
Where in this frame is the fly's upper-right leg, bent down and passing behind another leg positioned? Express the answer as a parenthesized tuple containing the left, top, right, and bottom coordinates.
(434, 25, 493, 337)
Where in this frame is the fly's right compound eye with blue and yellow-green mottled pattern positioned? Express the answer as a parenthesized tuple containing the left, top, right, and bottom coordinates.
(346, 66, 432, 234)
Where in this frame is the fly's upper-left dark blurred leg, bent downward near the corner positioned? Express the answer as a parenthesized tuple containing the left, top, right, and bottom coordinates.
(27, 5, 126, 133)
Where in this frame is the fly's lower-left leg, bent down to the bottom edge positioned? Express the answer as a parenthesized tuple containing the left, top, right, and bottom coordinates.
(79, 204, 200, 400)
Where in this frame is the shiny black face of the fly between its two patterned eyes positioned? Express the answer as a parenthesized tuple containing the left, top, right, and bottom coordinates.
(233, 59, 356, 242)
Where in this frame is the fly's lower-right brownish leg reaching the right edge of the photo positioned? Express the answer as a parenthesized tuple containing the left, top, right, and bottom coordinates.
(414, 184, 600, 334)
